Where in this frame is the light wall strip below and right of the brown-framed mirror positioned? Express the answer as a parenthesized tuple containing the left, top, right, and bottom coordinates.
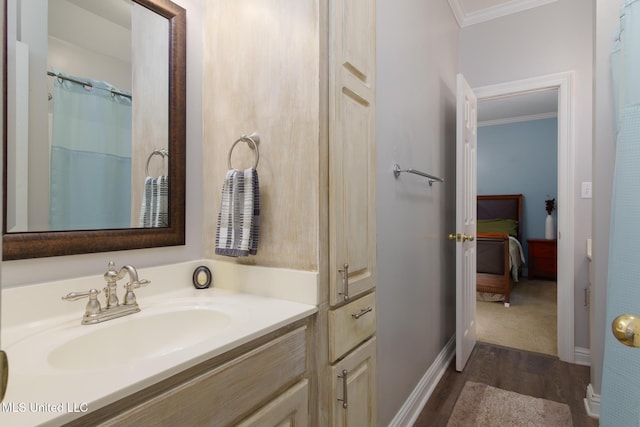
(2, 0, 203, 291)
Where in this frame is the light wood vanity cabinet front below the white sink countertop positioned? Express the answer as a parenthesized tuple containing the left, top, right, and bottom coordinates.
(69, 319, 309, 426)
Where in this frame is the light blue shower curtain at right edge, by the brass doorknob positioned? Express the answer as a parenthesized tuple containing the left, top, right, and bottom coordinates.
(592, 0, 640, 426)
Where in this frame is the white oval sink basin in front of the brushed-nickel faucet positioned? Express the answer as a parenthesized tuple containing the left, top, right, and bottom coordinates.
(47, 308, 231, 370)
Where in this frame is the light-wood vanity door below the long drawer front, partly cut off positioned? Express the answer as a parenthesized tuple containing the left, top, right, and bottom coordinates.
(238, 380, 309, 427)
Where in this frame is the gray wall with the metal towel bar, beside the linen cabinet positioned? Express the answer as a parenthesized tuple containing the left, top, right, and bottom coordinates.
(376, 0, 459, 426)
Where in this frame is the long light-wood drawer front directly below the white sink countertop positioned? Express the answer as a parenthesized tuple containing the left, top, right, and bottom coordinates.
(101, 327, 307, 426)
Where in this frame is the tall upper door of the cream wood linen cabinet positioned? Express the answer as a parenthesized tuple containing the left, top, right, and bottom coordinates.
(329, 0, 376, 305)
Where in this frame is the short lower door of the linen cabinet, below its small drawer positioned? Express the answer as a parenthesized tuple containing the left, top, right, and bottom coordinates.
(331, 337, 378, 427)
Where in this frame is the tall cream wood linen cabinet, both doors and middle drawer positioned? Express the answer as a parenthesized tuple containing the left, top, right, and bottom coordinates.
(328, 0, 377, 426)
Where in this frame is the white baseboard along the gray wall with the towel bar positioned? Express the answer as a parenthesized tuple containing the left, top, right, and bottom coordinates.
(389, 335, 456, 427)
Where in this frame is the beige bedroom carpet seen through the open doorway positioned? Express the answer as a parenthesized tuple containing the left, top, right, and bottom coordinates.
(476, 278, 558, 356)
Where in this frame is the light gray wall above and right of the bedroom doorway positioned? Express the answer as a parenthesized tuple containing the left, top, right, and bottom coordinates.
(460, 0, 594, 348)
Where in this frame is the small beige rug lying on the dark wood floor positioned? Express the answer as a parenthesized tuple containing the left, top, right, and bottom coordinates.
(447, 381, 573, 427)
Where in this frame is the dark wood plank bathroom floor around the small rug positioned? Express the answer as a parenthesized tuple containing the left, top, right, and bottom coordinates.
(414, 342, 598, 427)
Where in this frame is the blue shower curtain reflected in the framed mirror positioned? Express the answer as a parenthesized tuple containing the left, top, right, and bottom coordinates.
(49, 70, 131, 230)
